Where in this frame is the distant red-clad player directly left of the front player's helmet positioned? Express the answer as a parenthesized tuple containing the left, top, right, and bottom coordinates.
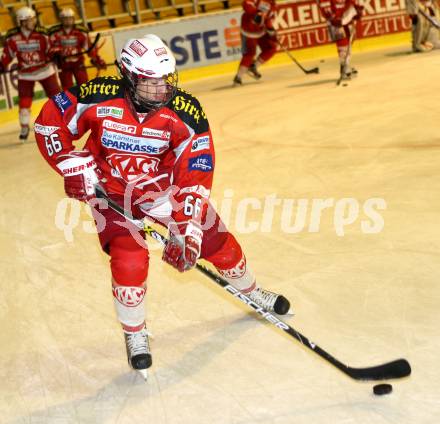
(49, 8, 106, 90)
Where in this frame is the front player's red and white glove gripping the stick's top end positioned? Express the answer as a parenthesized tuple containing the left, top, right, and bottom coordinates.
(57, 150, 100, 201)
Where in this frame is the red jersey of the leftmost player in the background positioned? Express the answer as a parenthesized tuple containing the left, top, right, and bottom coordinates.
(0, 26, 55, 81)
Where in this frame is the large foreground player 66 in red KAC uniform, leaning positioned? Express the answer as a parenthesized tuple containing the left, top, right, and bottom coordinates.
(35, 34, 289, 376)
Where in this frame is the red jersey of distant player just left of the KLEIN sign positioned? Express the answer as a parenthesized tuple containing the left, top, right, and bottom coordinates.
(241, 0, 276, 38)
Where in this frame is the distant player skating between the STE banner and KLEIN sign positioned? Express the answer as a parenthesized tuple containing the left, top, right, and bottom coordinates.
(234, 0, 277, 85)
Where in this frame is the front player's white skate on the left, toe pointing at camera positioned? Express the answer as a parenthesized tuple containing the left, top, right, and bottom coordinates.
(124, 327, 153, 380)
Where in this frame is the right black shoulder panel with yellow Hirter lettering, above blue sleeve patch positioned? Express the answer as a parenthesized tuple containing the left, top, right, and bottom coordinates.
(167, 88, 209, 133)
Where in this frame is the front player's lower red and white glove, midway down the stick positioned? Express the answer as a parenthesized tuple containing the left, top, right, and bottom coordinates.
(162, 220, 203, 272)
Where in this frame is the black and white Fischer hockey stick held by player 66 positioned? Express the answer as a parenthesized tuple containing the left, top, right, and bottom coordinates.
(95, 185, 411, 380)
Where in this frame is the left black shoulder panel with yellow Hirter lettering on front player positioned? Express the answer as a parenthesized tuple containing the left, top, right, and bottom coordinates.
(69, 77, 124, 103)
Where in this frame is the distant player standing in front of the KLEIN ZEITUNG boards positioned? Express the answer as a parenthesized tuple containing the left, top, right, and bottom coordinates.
(318, 0, 363, 80)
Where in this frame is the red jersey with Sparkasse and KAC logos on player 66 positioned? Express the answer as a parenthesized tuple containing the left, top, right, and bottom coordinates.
(34, 77, 214, 222)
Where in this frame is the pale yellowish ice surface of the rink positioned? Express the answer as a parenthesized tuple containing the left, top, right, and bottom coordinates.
(0, 44, 440, 424)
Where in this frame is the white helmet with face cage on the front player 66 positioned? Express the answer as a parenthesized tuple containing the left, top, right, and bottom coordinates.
(119, 34, 177, 110)
